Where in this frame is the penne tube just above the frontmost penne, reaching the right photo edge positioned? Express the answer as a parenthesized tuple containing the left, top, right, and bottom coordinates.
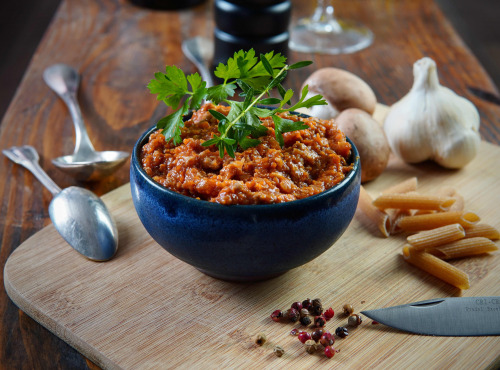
(429, 237, 498, 260)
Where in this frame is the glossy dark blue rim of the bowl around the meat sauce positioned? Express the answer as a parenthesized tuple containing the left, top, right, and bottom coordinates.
(131, 112, 361, 211)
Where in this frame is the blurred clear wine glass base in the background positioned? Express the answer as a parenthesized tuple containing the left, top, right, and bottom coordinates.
(289, 0, 373, 54)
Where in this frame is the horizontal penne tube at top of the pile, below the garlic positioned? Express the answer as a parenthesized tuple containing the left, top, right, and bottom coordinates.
(373, 192, 455, 211)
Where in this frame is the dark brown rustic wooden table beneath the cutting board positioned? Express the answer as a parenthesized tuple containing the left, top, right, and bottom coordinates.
(0, 0, 500, 369)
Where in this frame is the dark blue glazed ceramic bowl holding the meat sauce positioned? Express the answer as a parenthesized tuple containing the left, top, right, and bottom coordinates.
(130, 121, 361, 281)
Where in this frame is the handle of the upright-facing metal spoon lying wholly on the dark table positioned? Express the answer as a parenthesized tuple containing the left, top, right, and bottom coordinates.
(43, 64, 95, 161)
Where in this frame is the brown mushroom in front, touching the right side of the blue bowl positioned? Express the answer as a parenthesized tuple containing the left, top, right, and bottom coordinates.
(335, 108, 391, 183)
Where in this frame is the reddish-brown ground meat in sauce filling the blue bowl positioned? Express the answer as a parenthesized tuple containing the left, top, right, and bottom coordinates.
(141, 104, 352, 204)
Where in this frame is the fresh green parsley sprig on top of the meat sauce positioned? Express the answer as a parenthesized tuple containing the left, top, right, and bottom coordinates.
(148, 49, 327, 158)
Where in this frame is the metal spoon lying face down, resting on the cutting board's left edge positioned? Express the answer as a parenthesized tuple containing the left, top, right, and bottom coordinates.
(2, 145, 118, 261)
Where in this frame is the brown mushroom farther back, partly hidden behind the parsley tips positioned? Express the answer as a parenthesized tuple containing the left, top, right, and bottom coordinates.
(302, 67, 377, 119)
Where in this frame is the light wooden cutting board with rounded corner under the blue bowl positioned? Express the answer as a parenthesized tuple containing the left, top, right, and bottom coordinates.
(4, 142, 500, 369)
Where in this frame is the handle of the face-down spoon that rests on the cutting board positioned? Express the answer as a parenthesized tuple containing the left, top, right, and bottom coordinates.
(2, 145, 61, 195)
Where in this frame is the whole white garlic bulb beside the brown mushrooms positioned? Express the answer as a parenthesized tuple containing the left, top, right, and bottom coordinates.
(384, 57, 481, 168)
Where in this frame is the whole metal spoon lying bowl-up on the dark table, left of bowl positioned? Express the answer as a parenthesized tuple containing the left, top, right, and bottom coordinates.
(43, 64, 129, 181)
